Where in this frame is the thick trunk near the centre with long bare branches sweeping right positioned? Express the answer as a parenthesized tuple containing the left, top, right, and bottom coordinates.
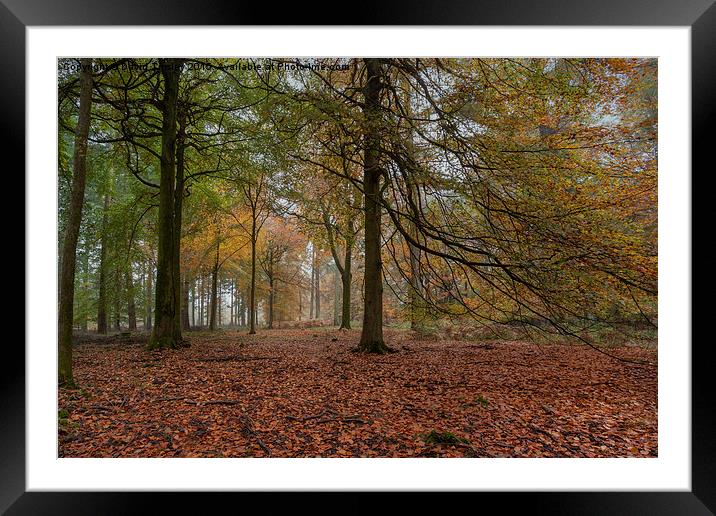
(358, 58, 388, 353)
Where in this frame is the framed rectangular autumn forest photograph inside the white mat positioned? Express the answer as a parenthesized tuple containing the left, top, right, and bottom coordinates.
(58, 57, 666, 463)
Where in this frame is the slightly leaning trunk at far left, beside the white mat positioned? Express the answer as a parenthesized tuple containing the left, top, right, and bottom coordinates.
(57, 59, 92, 386)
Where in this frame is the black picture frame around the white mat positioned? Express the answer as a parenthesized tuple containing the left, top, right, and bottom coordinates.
(7, 0, 716, 515)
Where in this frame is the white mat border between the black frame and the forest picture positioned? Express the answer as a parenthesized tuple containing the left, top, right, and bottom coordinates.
(25, 27, 691, 491)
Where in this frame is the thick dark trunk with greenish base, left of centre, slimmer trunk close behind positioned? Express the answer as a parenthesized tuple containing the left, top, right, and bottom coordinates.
(148, 59, 181, 349)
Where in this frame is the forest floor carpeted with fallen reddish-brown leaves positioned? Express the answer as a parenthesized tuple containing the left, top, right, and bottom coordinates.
(59, 328, 657, 457)
